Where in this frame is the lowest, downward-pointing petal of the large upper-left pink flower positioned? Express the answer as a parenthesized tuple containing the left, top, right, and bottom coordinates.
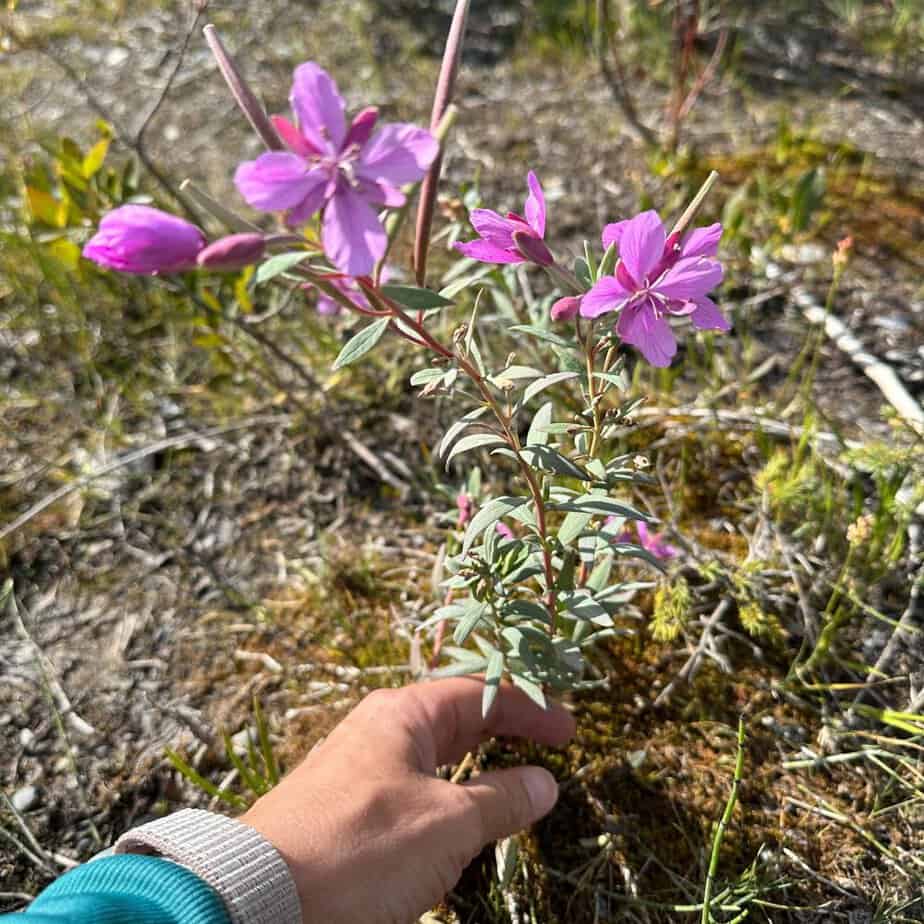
(321, 183, 388, 276)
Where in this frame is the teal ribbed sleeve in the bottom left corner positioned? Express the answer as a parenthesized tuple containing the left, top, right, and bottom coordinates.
(0, 854, 231, 924)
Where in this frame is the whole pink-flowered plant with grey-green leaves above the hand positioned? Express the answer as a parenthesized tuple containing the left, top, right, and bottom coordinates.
(84, 19, 729, 714)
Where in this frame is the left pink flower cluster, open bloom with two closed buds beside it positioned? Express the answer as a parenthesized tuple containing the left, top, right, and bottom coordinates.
(83, 62, 439, 277)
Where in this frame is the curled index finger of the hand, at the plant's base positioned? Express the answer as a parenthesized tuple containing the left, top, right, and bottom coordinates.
(401, 677, 575, 773)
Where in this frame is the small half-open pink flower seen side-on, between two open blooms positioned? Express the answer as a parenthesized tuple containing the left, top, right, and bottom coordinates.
(456, 170, 555, 266)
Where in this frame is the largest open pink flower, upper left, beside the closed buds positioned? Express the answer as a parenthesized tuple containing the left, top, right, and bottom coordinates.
(234, 62, 439, 276)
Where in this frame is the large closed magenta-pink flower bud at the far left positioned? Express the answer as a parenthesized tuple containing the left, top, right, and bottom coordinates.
(83, 205, 205, 276)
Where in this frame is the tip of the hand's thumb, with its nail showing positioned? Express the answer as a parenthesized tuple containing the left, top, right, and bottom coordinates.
(465, 767, 558, 849)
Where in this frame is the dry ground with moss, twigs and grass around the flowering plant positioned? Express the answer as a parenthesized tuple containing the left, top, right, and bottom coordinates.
(0, 0, 924, 924)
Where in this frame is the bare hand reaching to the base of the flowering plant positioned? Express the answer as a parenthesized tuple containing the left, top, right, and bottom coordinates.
(241, 677, 574, 924)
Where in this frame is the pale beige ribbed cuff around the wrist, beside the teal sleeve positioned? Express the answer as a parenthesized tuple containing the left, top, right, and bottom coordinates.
(115, 809, 302, 924)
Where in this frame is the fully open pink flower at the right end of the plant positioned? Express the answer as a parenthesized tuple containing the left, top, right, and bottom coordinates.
(580, 211, 730, 366)
